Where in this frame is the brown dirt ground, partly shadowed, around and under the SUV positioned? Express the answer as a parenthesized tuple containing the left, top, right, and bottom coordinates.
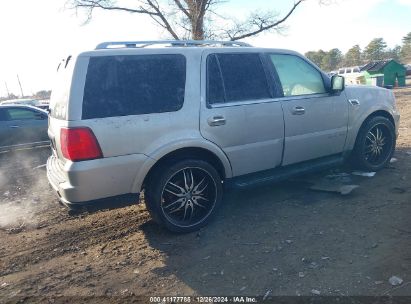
(0, 87, 411, 303)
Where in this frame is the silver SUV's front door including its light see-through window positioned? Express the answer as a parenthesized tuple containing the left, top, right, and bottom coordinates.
(268, 54, 348, 165)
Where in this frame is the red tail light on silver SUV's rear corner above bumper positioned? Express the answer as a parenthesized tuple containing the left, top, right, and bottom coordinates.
(60, 127, 103, 161)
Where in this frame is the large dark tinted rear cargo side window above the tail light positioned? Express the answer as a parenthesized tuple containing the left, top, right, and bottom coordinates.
(83, 54, 186, 119)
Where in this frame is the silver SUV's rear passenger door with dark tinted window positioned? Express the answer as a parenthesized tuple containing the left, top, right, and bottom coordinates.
(200, 50, 284, 176)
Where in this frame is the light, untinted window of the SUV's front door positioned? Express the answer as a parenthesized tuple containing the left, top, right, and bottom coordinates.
(270, 54, 326, 96)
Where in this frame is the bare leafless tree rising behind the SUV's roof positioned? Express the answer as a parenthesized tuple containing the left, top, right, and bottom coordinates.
(68, 0, 310, 41)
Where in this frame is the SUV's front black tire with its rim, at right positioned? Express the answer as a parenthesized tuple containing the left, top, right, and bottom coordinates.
(352, 116, 396, 171)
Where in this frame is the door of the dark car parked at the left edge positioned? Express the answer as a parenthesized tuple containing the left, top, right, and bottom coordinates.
(6, 107, 48, 145)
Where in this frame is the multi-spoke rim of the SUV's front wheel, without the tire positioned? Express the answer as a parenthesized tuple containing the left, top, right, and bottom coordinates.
(364, 124, 393, 166)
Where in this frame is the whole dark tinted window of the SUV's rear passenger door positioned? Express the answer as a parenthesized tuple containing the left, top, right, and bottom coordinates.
(207, 53, 271, 104)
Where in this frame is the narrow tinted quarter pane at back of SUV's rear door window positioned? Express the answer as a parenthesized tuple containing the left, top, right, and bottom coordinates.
(207, 55, 225, 104)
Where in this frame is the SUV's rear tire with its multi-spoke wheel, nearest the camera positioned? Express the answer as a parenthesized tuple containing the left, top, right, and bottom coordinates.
(145, 159, 223, 233)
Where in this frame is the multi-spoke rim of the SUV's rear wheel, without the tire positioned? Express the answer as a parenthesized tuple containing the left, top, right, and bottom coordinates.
(160, 167, 217, 227)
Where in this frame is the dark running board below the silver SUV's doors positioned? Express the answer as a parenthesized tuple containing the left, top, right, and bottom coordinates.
(226, 154, 344, 188)
